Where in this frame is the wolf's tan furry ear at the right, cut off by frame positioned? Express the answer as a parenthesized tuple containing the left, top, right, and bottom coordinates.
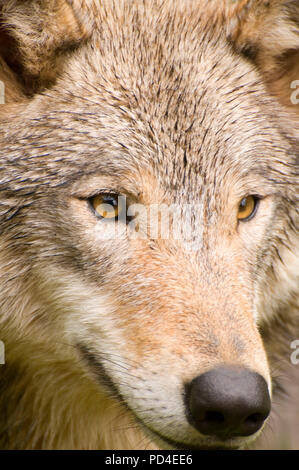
(229, 0, 299, 114)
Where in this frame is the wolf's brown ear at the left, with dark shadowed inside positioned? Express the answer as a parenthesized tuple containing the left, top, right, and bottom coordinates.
(0, 0, 87, 96)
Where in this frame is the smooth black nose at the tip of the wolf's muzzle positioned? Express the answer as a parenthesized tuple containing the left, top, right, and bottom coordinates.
(187, 367, 271, 439)
